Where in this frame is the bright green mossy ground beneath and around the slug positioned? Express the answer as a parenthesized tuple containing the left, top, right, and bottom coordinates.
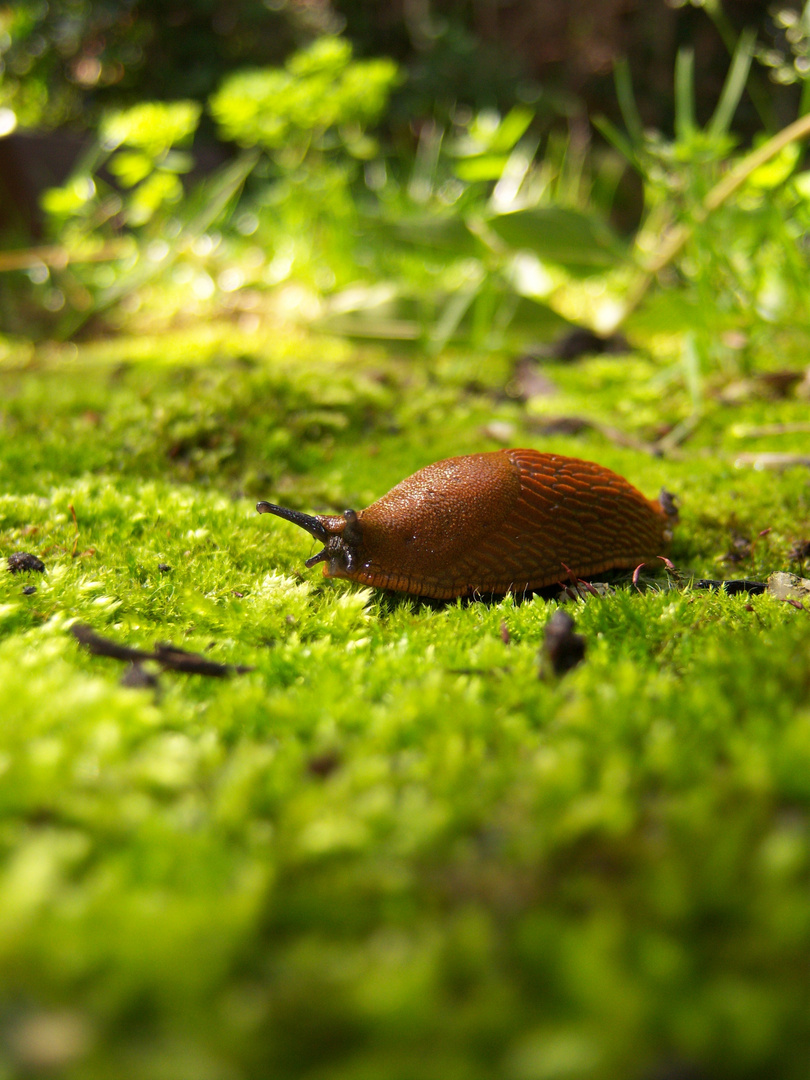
(0, 327, 810, 1080)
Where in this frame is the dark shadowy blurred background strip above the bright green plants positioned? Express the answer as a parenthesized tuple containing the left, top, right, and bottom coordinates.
(0, 0, 806, 132)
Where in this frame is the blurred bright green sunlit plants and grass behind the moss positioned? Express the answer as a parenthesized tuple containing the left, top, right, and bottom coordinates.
(0, 8, 808, 393)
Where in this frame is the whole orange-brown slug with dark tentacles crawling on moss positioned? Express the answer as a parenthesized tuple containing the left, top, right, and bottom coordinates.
(256, 449, 670, 599)
